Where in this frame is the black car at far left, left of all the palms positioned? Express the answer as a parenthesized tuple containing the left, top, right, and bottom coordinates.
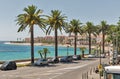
(0, 61, 17, 70)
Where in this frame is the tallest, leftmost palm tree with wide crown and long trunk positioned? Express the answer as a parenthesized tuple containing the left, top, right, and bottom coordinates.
(16, 5, 45, 64)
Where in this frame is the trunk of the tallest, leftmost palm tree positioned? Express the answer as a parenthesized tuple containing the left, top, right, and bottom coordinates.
(31, 26, 34, 64)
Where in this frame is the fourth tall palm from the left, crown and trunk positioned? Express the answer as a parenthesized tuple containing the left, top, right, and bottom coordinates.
(84, 22, 95, 54)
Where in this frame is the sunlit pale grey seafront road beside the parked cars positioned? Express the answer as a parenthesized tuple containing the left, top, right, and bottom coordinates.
(0, 58, 108, 79)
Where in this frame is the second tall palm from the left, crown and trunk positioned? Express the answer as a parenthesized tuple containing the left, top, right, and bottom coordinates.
(46, 10, 67, 59)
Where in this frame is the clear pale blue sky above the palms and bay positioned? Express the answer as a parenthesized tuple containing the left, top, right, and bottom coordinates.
(0, 0, 120, 41)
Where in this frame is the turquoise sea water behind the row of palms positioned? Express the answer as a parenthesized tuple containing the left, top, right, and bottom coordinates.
(0, 42, 88, 61)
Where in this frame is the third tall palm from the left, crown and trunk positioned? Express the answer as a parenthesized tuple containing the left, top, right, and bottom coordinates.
(67, 19, 82, 55)
